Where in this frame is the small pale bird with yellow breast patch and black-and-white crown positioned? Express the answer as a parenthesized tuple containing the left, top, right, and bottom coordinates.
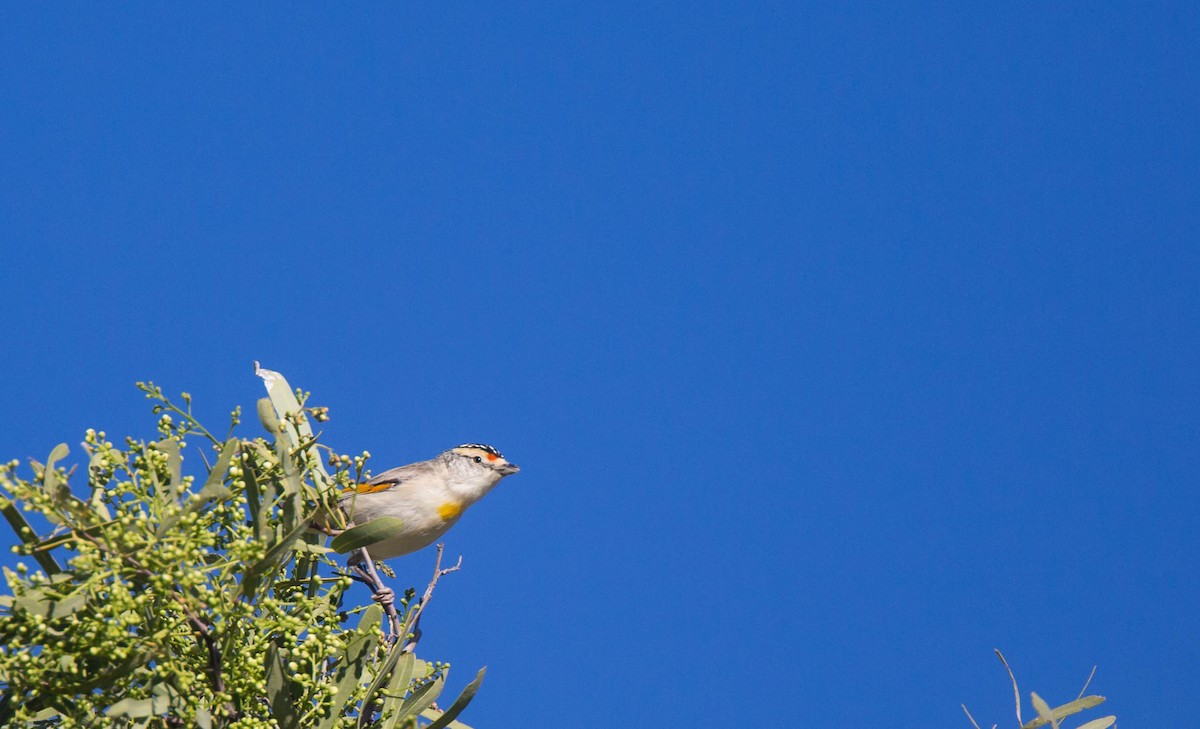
(340, 442, 521, 562)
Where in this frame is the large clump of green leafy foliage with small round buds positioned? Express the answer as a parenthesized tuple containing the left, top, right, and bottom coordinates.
(0, 373, 482, 729)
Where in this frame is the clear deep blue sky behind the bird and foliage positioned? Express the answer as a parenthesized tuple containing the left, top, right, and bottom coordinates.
(0, 2, 1200, 728)
